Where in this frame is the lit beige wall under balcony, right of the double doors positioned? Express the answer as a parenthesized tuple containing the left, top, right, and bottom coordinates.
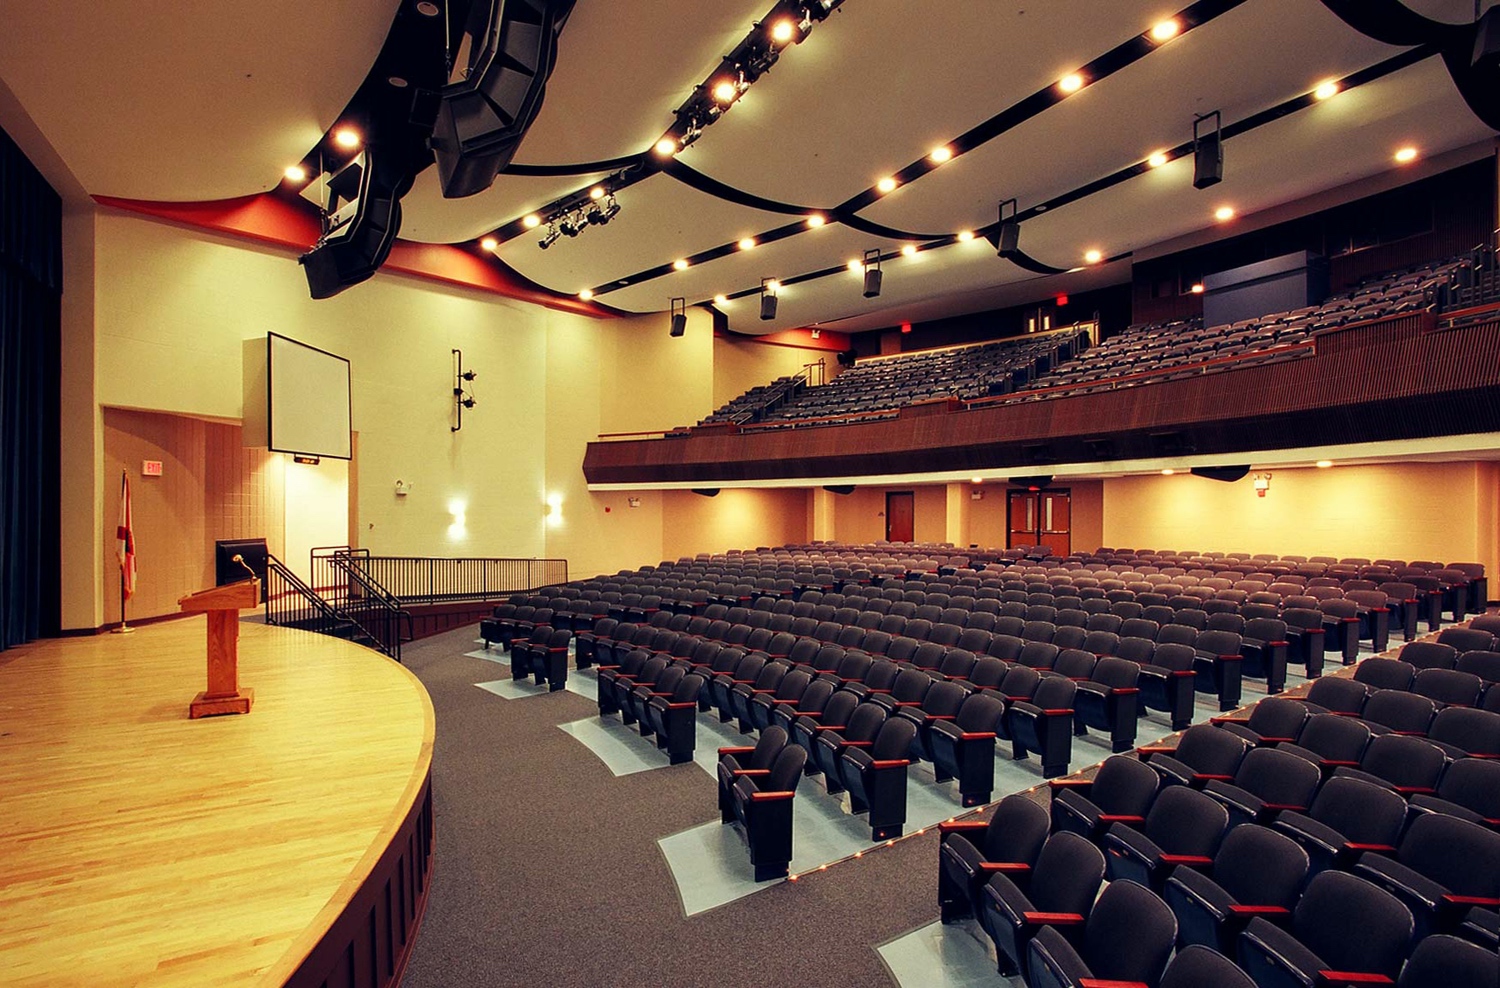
(1103, 462, 1497, 571)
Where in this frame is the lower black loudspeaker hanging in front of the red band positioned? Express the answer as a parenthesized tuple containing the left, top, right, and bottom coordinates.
(297, 148, 413, 298)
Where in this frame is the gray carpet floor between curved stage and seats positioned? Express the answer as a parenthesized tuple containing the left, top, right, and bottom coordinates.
(402, 628, 957, 988)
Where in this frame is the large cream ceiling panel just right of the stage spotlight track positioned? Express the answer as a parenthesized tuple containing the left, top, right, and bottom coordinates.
(683, 0, 1184, 208)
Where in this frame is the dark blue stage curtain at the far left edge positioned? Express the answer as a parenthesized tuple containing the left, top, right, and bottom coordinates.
(0, 123, 63, 648)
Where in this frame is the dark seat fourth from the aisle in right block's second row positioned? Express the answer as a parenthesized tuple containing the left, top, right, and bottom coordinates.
(1239, 871, 1413, 988)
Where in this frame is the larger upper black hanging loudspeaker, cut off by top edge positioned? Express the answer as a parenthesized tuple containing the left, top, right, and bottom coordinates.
(432, 0, 575, 199)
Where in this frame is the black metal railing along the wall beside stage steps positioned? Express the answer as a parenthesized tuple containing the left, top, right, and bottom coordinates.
(312, 546, 567, 607)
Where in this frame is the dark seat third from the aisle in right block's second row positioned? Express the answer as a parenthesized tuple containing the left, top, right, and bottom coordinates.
(1161, 826, 1310, 955)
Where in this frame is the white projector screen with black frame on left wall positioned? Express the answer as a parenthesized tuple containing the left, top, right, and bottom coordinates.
(266, 333, 350, 460)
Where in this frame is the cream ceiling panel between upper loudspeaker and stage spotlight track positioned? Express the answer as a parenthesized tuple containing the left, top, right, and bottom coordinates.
(510, 0, 770, 166)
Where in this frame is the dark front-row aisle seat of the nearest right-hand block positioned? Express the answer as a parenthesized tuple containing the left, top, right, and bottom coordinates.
(938, 793, 1049, 924)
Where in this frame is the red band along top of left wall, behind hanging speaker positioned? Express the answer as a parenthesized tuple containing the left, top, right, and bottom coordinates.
(95, 192, 624, 319)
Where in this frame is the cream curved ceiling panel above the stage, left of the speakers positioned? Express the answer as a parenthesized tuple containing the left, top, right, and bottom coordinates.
(0, 0, 399, 201)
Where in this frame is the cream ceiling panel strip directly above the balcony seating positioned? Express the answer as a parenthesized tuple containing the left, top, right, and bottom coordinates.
(1020, 58, 1491, 272)
